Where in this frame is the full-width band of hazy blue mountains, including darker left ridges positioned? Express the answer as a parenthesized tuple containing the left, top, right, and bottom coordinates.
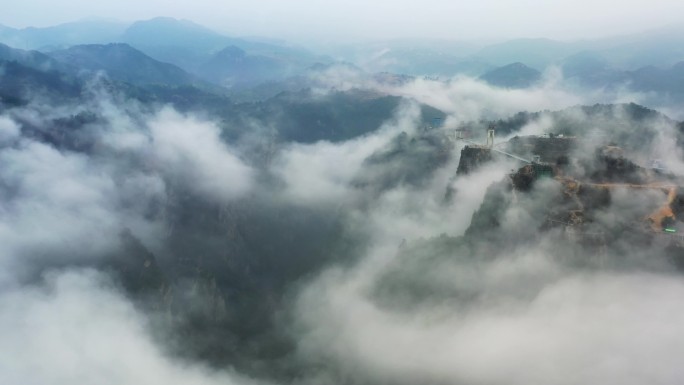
(0, 17, 684, 106)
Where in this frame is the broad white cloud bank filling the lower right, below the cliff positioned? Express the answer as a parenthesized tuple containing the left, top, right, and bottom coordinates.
(300, 244, 684, 384)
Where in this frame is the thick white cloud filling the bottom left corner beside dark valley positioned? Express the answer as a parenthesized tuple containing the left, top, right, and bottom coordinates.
(0, 271, 254, 385)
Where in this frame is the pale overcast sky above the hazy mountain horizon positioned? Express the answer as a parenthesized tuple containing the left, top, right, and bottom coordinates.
(0, 0, 684, 39)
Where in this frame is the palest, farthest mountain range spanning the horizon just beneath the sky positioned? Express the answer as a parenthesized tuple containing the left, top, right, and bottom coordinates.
(0, 17, 684, 83)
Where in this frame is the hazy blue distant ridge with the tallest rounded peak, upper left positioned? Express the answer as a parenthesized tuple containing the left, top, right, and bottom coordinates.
(0, 17, 329, 86)
